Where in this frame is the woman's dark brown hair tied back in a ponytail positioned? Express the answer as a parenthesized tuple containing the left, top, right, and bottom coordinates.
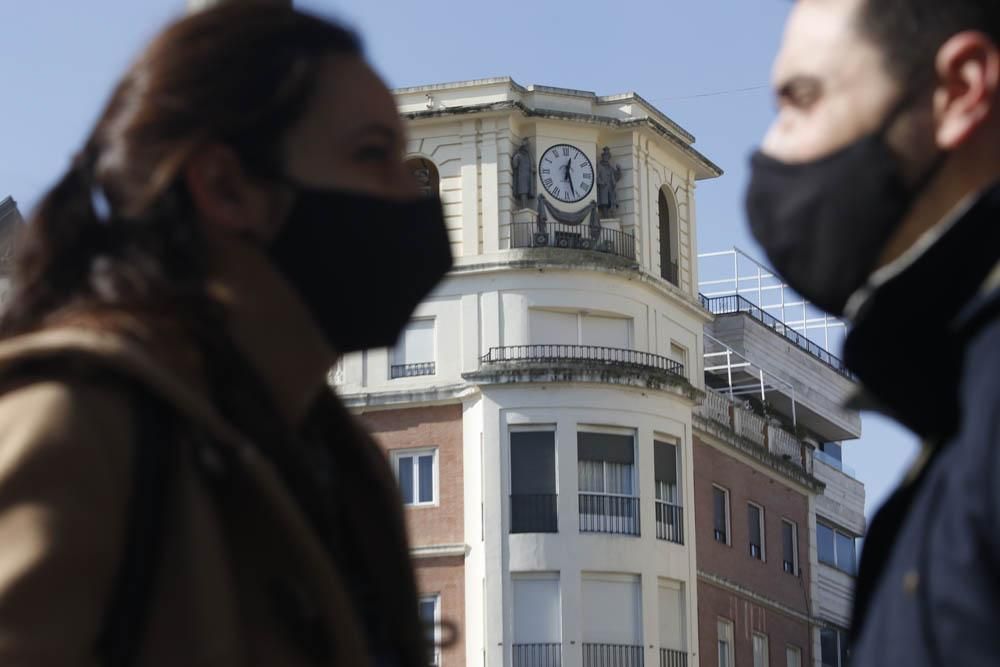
(0, 2, 361, 335)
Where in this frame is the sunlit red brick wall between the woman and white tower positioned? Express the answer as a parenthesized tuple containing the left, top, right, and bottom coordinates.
(361, 405, 465, 667)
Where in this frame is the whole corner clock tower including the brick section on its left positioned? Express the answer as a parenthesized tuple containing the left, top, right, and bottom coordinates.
(340, 78, 721, 667)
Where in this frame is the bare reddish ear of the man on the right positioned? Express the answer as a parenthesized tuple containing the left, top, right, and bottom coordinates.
(934, 31, 1000, 151)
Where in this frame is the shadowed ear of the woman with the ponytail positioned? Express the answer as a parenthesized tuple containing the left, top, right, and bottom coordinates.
(182, 143, 273, 239)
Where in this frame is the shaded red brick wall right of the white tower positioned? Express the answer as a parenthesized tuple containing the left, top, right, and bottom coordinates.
(694, 436, 812, 665)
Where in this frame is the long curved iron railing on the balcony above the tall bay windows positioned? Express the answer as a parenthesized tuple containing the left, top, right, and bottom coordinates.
(480, 344, 684, 378)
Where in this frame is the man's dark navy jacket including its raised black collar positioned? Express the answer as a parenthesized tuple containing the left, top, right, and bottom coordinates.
(845, 187, 1000, 667)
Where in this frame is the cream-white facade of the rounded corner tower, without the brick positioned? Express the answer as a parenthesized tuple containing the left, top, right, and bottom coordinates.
(335, 79, 720, 666)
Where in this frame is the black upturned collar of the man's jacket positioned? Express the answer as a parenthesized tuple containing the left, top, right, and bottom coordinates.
(844, 185, 1000, 440)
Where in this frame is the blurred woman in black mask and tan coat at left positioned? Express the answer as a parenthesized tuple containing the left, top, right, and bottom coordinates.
(0, 3, 451, 667)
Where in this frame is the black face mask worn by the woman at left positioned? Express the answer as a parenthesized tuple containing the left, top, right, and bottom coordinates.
(270, 184, 452, 353)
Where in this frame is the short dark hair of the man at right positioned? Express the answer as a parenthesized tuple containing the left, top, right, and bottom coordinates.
(859, 0, 1000, 81)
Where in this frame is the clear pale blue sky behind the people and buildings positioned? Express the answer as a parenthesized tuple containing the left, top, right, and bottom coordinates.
(0, 0, 915, 514)
